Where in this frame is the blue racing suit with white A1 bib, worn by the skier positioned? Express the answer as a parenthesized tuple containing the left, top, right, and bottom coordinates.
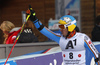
(33, 20, 99, 65)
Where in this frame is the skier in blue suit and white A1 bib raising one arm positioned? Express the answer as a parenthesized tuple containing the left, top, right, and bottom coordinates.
(26, 8, 99, 65)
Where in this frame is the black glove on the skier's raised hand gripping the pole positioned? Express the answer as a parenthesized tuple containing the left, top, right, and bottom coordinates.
(26, 5, 38, 23)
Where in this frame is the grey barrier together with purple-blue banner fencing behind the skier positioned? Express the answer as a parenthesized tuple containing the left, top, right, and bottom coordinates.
(0, 42, 100, 65)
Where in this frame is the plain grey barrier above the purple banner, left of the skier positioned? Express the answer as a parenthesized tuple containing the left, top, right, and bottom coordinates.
(0, 42, 58, 59)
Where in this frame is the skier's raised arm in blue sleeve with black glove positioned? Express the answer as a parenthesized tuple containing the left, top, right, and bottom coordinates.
(26, 6, 60, 44)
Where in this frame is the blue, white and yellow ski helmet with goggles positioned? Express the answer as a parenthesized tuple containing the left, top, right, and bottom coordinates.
(58, 15, 76, 32)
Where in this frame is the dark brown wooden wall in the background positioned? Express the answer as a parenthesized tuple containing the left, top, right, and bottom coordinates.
(0, 0, 100, 43)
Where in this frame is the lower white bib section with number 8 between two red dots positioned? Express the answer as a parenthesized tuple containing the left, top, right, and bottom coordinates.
(62, 51, 85, 65)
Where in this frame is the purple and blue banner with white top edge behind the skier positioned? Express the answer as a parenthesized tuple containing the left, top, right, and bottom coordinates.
(0, 44, 100, 65)
